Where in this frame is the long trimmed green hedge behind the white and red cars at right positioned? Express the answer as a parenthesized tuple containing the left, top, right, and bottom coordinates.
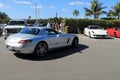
(63, 19, 120, 33)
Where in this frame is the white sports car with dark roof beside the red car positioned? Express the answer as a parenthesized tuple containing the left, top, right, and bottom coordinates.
(84, 25, 108, 38)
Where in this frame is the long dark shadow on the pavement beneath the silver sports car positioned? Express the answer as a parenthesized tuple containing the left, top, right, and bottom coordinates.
(14, 44, 89, 61)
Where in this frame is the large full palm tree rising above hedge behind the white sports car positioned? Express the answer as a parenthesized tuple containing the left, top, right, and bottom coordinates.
(84, 0, 106, 19)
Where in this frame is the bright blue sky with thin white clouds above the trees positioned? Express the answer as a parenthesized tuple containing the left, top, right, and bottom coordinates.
(0, 0, 119, 19)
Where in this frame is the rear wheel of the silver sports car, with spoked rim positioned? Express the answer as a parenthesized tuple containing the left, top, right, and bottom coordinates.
(35, 42, 48, 57)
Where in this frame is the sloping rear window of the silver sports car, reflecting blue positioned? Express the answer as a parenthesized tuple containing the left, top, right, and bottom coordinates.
(20, 28, 40, 35)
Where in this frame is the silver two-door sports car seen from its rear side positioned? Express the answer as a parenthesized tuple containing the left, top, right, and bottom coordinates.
(5, 27, 79, 57)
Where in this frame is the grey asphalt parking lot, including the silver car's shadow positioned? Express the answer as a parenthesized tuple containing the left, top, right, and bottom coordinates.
(0, 35, 120, 80)
